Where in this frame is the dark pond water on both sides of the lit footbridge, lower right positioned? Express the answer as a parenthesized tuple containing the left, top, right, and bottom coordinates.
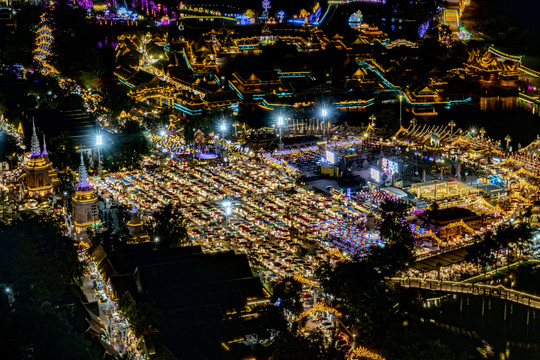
(424, 266, 540, 360)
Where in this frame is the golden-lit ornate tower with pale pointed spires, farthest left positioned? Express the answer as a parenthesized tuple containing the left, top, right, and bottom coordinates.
(21, 125, 58, 197)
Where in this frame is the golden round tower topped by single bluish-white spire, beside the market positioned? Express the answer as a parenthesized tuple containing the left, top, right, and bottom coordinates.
(71, 153, 101, 239)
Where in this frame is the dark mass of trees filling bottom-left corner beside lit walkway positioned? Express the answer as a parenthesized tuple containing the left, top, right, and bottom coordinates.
(0, 213, 96, 359)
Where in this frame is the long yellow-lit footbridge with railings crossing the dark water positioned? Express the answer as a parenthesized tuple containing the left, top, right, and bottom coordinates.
(390, 278, 540, 310)
